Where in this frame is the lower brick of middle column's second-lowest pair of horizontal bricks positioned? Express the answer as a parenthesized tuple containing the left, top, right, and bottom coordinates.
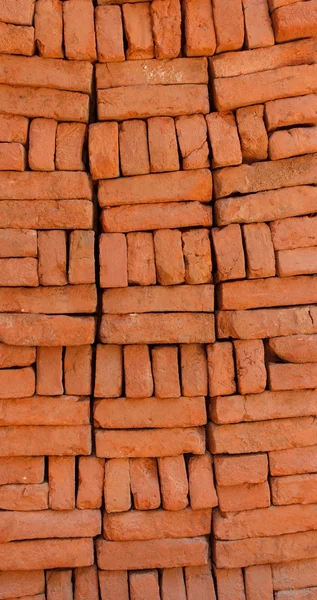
(96, 427, 205, 464)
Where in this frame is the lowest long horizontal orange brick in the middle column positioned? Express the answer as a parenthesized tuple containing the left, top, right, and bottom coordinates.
(97, 537, 208, 571)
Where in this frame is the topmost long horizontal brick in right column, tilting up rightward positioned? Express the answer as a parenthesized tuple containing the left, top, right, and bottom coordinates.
(209, 38, 316, 79)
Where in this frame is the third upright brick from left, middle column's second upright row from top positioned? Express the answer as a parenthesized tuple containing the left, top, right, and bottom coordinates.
(147, 117, 179, 173)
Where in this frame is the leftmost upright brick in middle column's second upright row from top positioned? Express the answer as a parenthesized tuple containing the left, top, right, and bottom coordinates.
(89, 122, 120, 179)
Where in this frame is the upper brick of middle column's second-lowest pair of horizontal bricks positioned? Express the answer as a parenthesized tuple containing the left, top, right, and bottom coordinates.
(94, 396, 206, 429)
